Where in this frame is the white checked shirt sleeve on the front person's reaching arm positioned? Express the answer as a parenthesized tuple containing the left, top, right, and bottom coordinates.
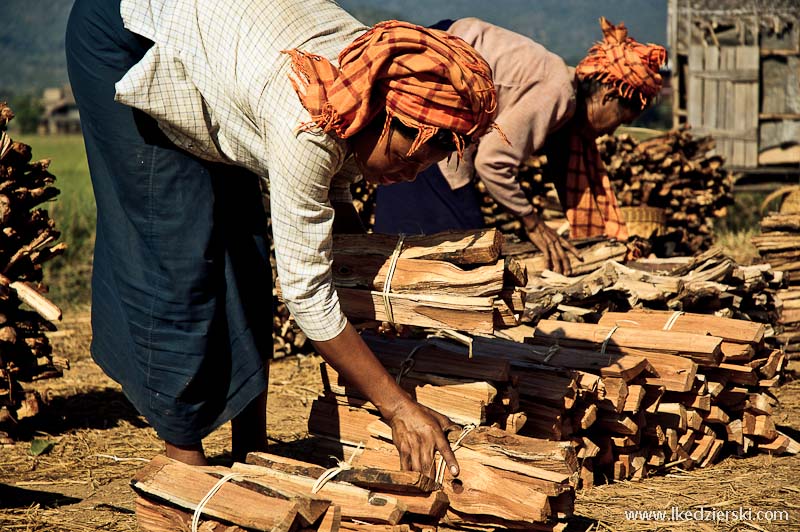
(263, 72, 354, 341)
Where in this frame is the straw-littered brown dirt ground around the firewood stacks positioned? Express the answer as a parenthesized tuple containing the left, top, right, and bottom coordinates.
(0, 315, 800, 532)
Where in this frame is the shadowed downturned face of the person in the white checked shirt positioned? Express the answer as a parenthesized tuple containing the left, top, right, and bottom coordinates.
(350, 118, 450, 185)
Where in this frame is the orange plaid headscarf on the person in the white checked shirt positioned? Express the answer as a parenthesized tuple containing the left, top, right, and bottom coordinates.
(284, 20, 497, 156)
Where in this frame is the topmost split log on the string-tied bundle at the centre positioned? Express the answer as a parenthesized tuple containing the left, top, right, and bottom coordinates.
(333, 229, 503, 264)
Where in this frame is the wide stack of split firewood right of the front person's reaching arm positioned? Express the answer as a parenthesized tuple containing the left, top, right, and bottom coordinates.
(332, 310, 800, 483)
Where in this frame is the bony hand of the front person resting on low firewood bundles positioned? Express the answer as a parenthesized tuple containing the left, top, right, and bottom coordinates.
(388, 400, 459, 478)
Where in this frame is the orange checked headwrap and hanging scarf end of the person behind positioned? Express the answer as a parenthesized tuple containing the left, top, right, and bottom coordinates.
(565, 17, 667, 240)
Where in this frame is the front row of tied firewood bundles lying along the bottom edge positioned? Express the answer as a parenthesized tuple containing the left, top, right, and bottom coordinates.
(136, 440, 577, 532)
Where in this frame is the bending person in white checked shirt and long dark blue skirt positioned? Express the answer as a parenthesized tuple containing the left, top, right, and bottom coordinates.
(66, 0, 496, 475)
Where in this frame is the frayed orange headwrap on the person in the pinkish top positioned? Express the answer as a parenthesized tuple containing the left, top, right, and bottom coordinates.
(575, 17, 667, 109)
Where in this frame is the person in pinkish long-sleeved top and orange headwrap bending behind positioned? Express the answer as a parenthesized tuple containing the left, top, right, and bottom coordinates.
(375, 18, 667, 274)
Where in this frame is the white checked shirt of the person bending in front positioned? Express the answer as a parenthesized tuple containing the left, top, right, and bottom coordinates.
(116, 0, 367, 340)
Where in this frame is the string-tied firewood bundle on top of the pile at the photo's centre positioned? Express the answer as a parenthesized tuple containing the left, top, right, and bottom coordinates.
(278, 229, 527, 333)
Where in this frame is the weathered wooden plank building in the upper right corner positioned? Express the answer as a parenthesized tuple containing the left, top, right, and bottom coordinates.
(667, 0, 800, 171)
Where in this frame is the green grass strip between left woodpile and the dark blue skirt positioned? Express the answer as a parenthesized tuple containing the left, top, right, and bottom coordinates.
(13, 135, 96, 309)
